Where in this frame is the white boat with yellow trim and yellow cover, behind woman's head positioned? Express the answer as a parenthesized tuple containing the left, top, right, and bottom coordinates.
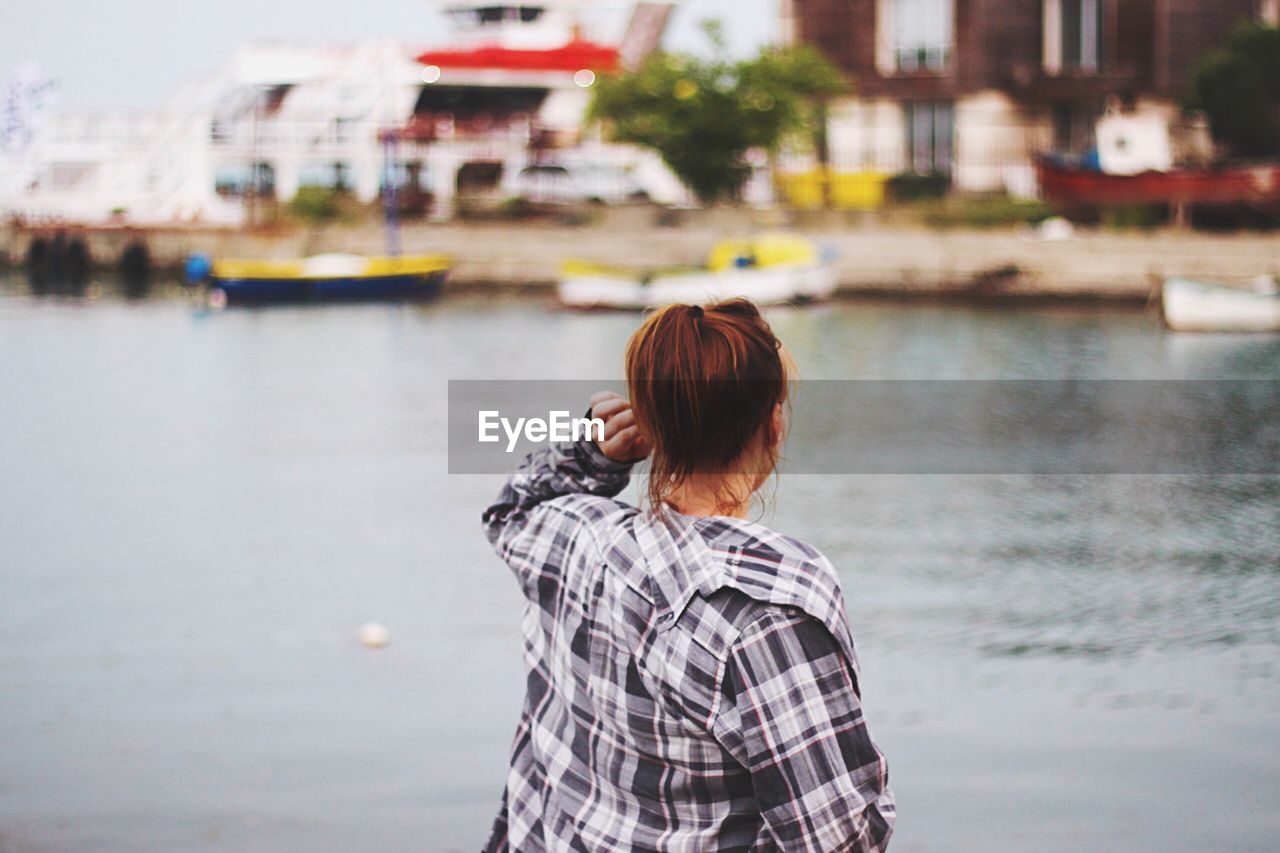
(558, 234, 836, 309)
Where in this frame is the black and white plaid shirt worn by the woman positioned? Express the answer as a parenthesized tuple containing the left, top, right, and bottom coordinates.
(484, 441, 895, 853)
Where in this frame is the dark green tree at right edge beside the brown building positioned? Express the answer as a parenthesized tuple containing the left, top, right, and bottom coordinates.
(1187, 22, 1280, 158)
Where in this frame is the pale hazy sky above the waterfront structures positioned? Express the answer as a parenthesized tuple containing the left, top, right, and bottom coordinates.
(0, 0, 777, 109)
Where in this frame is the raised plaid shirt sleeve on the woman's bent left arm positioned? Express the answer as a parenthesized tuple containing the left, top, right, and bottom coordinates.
(481, 437, 632, 583)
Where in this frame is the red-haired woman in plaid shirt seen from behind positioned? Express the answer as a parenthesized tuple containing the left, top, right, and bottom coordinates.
(484, 300, 895, 852)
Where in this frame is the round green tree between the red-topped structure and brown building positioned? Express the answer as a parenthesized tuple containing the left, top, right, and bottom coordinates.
(589, 22, 846, 204)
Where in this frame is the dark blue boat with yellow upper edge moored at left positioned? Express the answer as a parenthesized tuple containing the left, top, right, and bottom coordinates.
(209, 254, 451, 307)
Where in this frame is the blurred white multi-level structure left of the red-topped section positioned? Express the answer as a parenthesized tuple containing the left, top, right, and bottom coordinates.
(0, 40, 421, 225)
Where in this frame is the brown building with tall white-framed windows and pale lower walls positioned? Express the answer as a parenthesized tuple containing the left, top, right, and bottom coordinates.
(782, 0, 1280, 196)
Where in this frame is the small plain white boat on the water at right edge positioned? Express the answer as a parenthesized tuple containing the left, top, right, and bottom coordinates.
(1162, 277, 1280, 332)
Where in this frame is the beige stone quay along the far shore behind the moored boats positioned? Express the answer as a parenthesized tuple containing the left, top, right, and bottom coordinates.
(3, 207, 1280, 298)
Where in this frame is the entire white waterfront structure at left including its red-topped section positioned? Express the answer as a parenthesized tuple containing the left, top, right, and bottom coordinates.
(0, 0, 678, 225)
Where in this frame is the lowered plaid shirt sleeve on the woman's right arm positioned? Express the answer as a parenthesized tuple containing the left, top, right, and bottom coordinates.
(712, 607, 895, 853)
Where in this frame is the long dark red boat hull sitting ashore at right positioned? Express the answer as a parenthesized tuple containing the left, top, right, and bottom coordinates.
(1036, 158, 1280, 207)
